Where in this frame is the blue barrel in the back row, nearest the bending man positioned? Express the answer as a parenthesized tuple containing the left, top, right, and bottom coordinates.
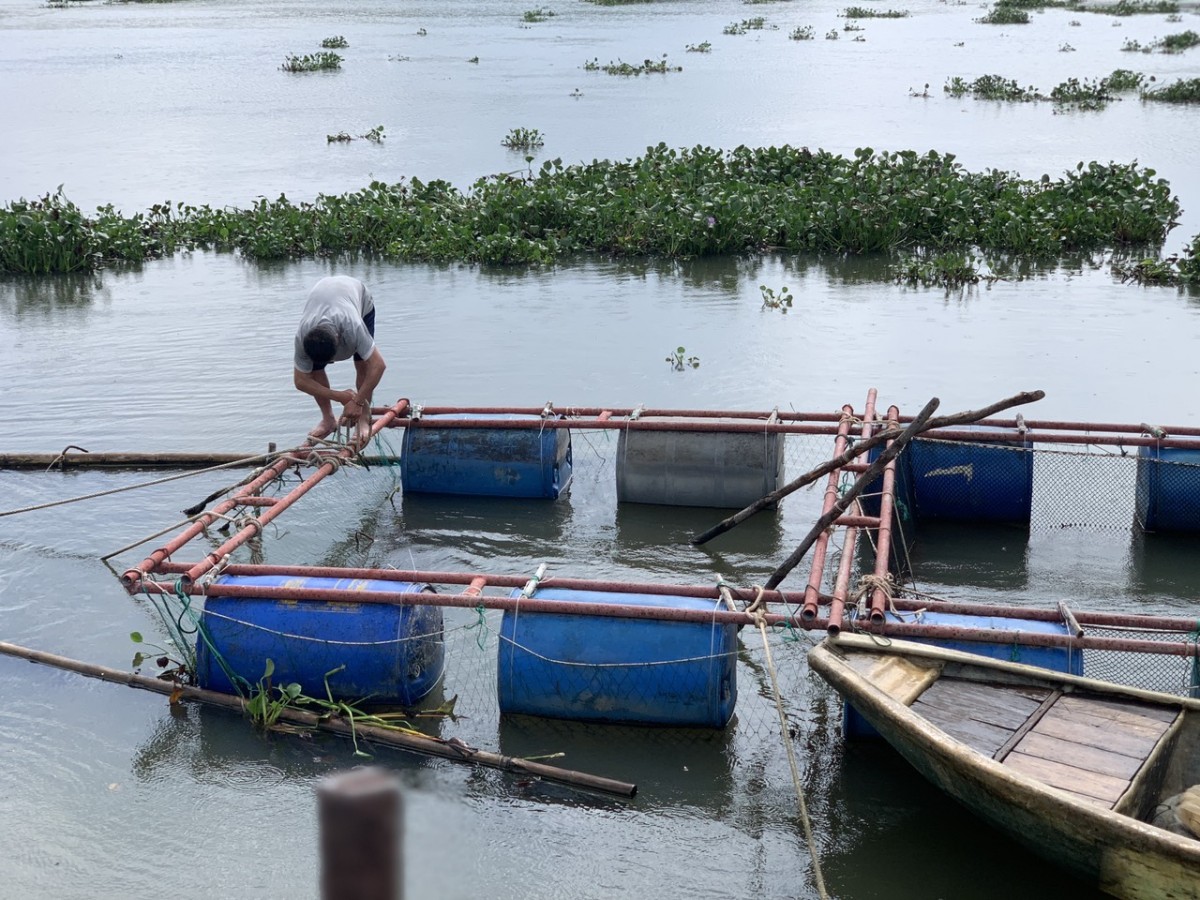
(400, 413, 571, 499)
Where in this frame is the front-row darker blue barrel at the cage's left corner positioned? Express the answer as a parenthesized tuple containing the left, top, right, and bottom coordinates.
(196, 575, 445, 706)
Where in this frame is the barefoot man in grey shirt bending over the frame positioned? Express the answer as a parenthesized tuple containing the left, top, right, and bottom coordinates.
(293, 275, 386, 440)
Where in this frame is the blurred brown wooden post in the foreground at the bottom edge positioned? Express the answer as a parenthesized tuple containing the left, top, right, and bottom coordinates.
(317, 766, 403, 900)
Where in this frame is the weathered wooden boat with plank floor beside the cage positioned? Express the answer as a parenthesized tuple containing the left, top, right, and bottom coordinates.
(809, 634, 1200, 900)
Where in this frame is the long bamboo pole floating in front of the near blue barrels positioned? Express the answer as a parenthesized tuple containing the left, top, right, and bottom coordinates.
(0, 641, 637, 797)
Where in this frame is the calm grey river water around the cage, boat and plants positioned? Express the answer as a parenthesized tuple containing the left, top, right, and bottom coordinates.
(0, 0, 1200, 899)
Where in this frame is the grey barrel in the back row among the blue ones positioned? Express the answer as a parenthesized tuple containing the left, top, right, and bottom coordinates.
(617, 416, 784, 509)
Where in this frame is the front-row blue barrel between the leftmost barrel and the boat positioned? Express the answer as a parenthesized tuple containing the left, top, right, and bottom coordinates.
(497, 588, 738, 728)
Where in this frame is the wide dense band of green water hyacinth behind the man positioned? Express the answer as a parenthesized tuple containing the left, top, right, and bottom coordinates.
(0, 144, 1180, 274)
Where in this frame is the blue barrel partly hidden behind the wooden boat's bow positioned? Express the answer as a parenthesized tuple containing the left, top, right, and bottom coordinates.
(842, 610, 1084, 738)
